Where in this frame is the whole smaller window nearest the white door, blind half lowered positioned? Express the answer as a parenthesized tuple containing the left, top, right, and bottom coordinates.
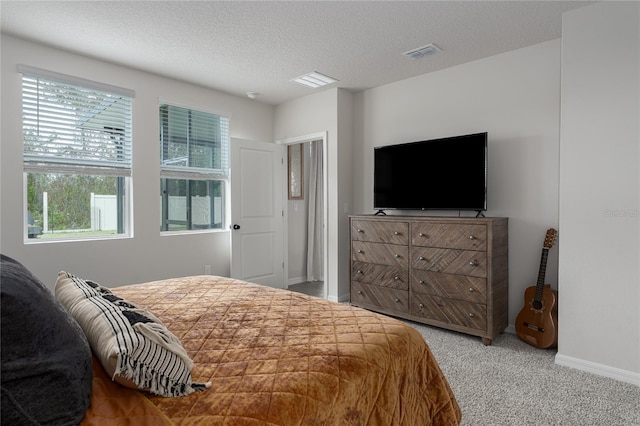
(160, 104, 230, 231)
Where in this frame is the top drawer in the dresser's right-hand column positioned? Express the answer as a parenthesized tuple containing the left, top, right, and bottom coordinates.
(411, 222, 487, 251)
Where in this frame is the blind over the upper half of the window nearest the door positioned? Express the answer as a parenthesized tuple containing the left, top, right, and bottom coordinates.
(160, 104, 230, 180)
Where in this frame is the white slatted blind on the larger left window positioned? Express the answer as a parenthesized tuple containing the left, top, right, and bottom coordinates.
(18, 66, 133, 176)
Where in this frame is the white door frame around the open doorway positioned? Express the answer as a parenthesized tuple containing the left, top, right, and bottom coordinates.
(276, 130, 329, 299)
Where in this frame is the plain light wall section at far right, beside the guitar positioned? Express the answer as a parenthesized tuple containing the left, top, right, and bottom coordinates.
(556, 2, 640, 385)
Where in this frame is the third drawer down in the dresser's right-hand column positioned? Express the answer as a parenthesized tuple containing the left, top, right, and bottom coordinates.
(410, 269, 487, 303)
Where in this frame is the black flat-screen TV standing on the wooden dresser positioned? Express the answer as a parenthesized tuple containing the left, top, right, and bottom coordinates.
(373, 132, 487, 211)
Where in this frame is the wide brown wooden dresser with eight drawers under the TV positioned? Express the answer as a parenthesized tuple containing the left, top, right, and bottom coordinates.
(349, 215, 509, 345)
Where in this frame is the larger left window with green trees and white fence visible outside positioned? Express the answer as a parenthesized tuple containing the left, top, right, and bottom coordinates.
(18, 66, 134, 239)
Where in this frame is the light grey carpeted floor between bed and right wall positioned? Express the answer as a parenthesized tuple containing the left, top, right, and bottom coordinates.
(408, 322, 640, 426)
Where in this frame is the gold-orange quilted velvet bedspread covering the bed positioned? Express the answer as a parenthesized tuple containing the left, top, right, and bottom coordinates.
(87, 276, 461, 425)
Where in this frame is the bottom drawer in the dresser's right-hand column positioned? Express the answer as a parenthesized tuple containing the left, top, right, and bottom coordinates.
(411, 294, 487, 330)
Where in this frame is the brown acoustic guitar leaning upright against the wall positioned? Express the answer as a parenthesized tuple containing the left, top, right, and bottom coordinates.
(516, 228, 558, 348)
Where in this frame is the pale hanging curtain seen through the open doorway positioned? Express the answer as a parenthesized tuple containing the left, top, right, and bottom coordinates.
(307, 141, 324, 281)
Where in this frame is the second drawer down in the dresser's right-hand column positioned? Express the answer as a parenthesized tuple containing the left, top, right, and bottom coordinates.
(411, 247, 487, 278)
